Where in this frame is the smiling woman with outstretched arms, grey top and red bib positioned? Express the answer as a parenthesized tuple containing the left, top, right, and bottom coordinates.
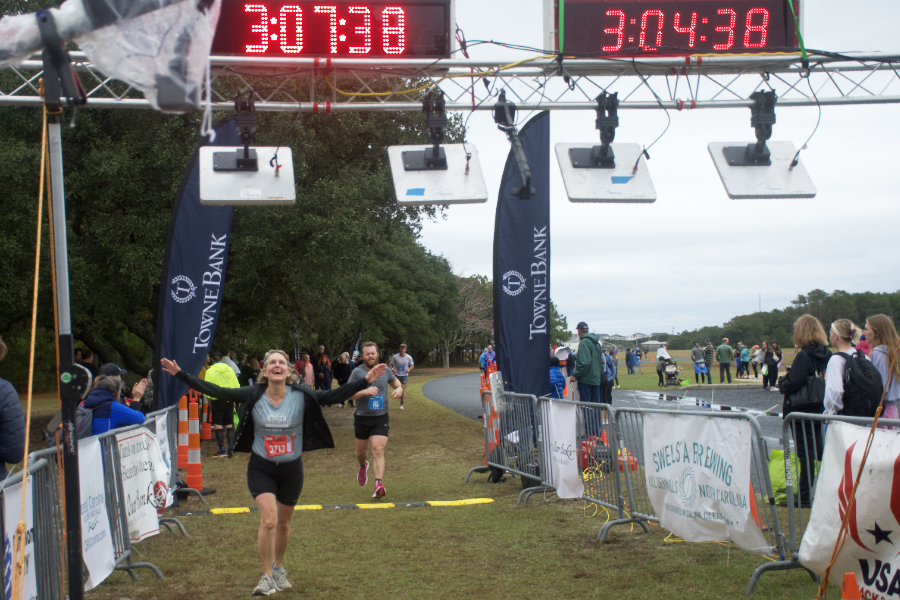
(160, 350, 387, 596)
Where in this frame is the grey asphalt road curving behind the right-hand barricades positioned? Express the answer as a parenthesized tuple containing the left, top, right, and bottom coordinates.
(422, 373, 782, 449)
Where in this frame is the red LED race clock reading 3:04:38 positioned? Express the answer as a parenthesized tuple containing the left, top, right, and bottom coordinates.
(559, 0, 797, 56)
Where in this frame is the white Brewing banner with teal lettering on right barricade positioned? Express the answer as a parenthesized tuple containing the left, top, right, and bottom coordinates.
(643, 413, 772, 554)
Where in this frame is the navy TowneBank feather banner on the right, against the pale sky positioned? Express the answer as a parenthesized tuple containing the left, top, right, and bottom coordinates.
(494, 111, 550, 396)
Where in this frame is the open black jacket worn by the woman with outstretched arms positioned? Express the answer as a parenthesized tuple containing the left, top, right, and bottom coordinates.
(176, 371, 369, 452)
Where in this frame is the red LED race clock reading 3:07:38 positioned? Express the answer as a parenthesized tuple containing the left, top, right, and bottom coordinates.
(212, 0, 451, 58)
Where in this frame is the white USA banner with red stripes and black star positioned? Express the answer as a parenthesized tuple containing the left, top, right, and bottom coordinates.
(800, 423, 900, 599)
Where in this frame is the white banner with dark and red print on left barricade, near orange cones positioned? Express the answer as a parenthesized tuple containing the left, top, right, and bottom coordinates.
(116, 428, 169, 543)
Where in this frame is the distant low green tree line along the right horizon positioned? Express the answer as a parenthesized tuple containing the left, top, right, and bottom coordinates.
(668, 289, 900, 350)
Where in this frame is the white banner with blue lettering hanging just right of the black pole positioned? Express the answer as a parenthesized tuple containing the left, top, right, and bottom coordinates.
(78, 437, 116, 591)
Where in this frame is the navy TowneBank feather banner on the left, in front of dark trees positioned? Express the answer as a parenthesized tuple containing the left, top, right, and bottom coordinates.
(153, 117, 241, 410)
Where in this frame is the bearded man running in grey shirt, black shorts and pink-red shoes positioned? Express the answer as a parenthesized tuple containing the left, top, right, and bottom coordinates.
(347, 342, 403, 498)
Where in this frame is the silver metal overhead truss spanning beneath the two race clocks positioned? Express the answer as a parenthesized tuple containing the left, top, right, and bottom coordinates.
(0, 51, 900, 113)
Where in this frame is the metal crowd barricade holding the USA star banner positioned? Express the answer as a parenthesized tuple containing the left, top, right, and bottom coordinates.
(768, 413, 900, 594)
